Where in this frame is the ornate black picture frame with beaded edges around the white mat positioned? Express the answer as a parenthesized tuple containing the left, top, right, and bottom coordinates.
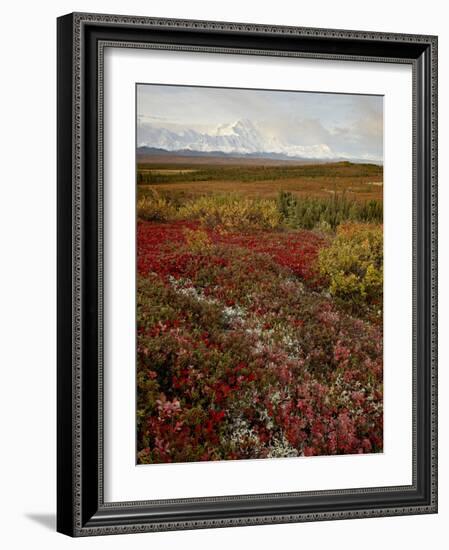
(57, 13, 437, 536)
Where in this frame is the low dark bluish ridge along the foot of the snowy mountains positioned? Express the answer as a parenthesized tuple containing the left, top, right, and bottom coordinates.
(137, 146, 383, 166)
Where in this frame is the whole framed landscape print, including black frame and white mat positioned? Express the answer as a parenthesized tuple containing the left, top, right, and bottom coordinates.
(57, 13, 437, 536)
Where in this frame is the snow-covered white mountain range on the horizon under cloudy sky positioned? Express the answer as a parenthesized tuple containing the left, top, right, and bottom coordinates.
(138, 119, 333, 159)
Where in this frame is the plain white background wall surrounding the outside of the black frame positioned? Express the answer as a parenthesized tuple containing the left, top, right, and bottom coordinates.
(0, 0, 449, 549)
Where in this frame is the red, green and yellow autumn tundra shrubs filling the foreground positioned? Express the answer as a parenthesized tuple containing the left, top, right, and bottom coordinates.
(137, 211, 383, 464)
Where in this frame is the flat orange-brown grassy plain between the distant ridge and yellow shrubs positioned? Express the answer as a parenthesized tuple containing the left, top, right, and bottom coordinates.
(137, 162, 383, 201)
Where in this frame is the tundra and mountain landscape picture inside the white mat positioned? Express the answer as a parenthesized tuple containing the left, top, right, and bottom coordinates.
(135, 82, 384, 465)
